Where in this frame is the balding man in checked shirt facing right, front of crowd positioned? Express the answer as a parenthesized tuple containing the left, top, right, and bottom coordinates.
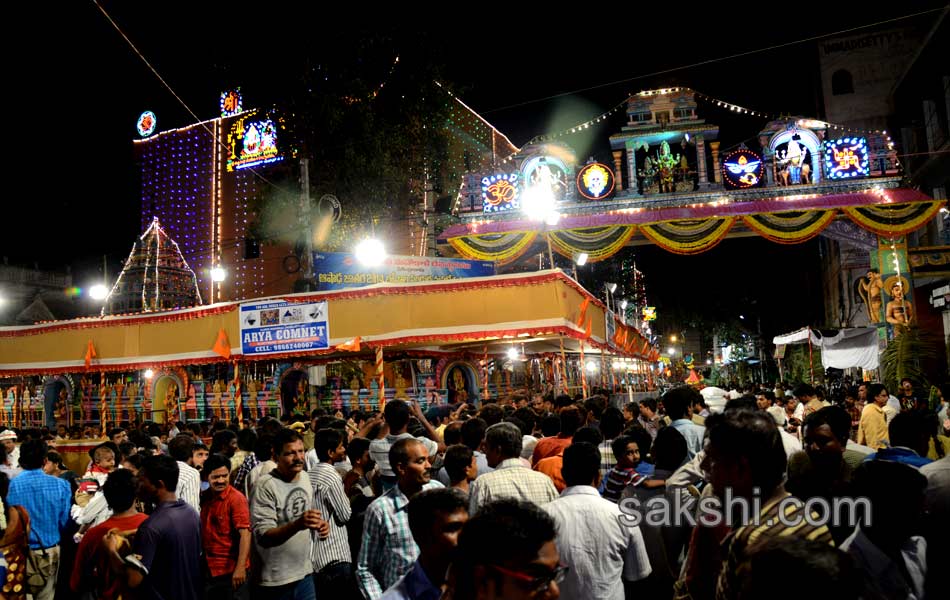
(356, 436, 444, 600)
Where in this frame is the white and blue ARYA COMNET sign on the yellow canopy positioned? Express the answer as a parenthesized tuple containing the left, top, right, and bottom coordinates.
(241, 300, 330, 355)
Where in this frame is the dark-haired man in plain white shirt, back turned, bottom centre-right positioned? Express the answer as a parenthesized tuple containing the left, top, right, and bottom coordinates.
(542, 442, 651, 600)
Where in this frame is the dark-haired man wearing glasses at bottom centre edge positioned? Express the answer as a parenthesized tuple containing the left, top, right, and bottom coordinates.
(446, 500, 567, 600)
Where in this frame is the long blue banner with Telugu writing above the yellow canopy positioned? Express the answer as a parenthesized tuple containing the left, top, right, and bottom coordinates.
(313, 252, 495, 291)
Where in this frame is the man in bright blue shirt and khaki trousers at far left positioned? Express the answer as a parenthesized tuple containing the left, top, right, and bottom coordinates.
(7, 440, 72, 600)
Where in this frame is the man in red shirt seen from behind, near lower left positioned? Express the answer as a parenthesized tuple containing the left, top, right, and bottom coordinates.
(69, 469, 148, 600)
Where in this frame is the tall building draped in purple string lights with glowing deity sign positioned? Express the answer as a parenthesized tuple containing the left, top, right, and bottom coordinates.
(133, 101, 294, 302)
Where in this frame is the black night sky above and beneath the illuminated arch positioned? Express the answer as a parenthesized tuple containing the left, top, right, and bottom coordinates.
(0, 1, 942, 338)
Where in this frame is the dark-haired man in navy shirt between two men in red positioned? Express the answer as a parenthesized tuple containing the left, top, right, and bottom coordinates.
(103, 455, 204, 600)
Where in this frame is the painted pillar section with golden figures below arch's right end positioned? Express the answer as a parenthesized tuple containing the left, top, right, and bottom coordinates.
(865, 236, 917, 346)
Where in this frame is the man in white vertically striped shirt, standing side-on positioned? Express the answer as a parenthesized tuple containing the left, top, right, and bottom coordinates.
(308, 428, 356, 598)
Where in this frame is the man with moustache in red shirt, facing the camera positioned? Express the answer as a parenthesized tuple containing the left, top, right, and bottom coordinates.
(201, 454, 251, 600)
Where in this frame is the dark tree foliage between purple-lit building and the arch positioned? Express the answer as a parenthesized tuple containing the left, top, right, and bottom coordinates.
(249, 31, 458, 250)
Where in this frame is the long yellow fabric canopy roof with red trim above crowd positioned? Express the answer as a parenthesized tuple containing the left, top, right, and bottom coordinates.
(0, 270, 654, 376)
